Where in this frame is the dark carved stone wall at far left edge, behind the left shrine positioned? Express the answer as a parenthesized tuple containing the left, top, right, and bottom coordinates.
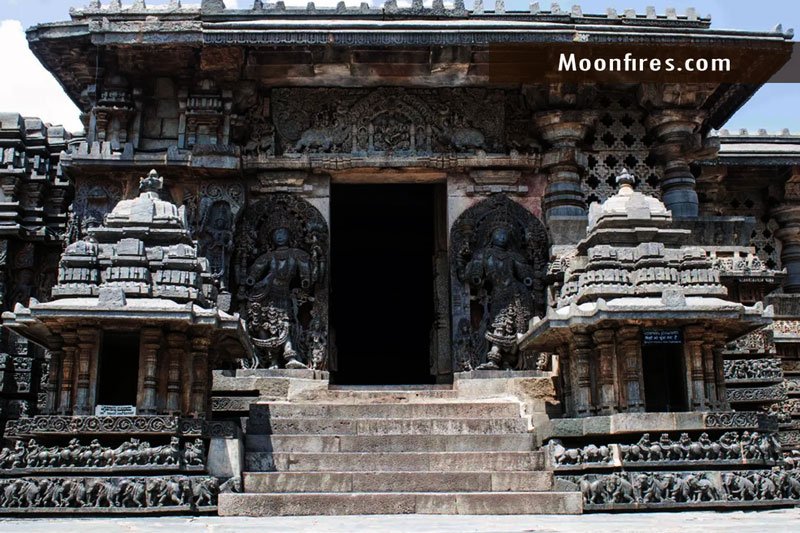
(0, 113, 72, 430)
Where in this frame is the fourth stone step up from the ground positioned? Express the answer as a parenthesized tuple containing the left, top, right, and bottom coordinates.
(245, 433, 535, 453)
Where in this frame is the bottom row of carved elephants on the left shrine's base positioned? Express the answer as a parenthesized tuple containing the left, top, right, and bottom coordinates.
(0, 476, 220, 509)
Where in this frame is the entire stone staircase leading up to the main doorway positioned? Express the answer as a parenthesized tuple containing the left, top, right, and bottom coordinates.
(219, 386, 582, 516)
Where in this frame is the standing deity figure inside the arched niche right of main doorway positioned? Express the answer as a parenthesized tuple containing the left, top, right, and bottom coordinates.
(461, 225, 534, 370)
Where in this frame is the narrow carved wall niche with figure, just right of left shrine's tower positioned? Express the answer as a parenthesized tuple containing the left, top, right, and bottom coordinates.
(197, 183, 244, 292)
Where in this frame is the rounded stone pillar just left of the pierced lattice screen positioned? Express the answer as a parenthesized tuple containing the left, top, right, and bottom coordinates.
(534, 110, 597, 225)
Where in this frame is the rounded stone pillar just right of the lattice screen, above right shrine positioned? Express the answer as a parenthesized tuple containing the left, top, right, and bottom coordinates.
(647, 109, 705, 218)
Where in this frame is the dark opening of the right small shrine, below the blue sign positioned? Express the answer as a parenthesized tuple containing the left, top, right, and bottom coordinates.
(642, 344, 688, 413)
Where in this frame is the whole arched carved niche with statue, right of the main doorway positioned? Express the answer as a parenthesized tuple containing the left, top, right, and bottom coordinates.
(450, 194, 548, 371)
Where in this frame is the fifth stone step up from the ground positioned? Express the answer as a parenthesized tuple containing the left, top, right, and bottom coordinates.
(247, 411, 528, 435)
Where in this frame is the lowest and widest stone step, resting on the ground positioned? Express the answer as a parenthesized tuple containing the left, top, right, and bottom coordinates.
(219, 492, 583, 516)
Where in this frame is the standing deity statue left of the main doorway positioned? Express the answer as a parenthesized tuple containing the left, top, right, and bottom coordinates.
(245, 227, 316, 368)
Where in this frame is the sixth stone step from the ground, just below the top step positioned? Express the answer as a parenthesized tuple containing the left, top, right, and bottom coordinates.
(258, 401, 520, 419)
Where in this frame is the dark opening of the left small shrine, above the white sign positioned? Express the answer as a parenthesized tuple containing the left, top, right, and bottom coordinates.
(97, 332, 139, 405)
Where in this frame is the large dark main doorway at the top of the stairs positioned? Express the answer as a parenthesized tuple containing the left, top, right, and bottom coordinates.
(331, 184, 436, 384)
